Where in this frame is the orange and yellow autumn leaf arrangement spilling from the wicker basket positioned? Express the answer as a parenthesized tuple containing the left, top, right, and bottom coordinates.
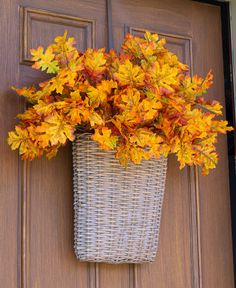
(8, 32, 232, 175)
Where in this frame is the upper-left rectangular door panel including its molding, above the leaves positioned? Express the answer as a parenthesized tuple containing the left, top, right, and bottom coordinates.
(20, 7, 95, 65)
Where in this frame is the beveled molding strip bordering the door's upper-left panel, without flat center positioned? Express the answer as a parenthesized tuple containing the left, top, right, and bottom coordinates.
(19, 6, 96, 65)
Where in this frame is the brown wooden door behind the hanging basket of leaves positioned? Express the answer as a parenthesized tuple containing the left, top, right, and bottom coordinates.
(0, 0, 233, 288)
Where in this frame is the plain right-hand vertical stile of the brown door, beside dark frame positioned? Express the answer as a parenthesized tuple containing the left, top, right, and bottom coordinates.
(192, 3, 233, 287)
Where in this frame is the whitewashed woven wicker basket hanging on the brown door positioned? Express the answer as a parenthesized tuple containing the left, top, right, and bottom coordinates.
(73, 134, 167, 263)
